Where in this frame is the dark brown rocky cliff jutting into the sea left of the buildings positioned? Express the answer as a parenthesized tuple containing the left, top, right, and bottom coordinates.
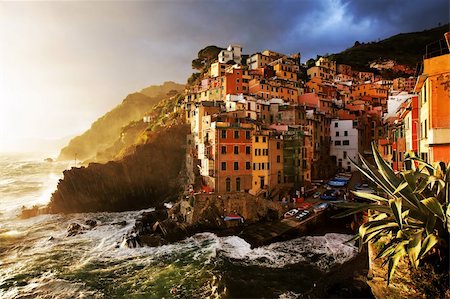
(49, 123, 189, 213)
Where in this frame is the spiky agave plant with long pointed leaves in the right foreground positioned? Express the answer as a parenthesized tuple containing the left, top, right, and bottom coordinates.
(335, 144, 450, 284)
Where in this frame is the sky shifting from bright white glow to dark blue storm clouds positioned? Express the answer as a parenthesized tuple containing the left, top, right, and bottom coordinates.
(0, 0, 449, 152)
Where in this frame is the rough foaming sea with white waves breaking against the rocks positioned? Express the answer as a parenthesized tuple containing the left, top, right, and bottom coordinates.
(0, 154, 357, 298)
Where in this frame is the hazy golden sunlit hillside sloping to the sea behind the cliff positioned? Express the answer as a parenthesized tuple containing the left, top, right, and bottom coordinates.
(58, 82, 184, 161)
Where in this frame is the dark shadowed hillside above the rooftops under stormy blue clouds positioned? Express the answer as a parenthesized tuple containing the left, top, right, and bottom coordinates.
(331, 24, 449, 71)
